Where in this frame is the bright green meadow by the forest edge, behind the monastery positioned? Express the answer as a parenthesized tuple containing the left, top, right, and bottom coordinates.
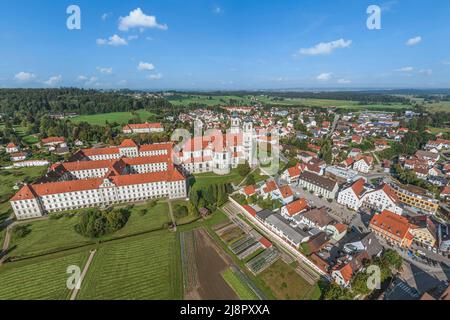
(71, 110, 155, 126)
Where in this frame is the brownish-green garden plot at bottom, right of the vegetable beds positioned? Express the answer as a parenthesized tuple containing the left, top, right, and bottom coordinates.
(258, 259, 321, 300)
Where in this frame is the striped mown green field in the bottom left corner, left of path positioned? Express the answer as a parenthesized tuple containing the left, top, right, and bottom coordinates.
(0, 252, 88, 300)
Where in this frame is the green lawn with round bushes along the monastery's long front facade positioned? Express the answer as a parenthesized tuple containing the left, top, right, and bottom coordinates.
(10, 202, 170, 258)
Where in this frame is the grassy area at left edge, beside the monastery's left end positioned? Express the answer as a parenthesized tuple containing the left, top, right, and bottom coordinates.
(0, 167, 47, 223)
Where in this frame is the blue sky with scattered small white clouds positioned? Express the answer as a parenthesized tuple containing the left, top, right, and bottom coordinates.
(0, 0, 450, 90)
